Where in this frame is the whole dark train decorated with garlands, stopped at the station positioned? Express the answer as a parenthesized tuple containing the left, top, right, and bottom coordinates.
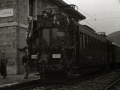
(26, 5, 120, 80)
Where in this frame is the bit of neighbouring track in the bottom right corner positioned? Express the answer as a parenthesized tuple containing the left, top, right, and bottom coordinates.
(104, 79, 120, 90)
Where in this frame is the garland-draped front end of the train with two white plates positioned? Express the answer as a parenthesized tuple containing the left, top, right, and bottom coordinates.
(27, 7, 76, 78)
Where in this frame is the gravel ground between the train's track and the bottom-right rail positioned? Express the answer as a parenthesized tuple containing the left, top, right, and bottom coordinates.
(31, 72, 120, 90)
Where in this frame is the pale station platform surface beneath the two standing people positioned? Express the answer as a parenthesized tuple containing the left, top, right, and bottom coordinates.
(0, 73, 39, 87)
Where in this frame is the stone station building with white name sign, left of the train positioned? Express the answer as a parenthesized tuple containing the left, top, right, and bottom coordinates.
(0, 0, 65, 75)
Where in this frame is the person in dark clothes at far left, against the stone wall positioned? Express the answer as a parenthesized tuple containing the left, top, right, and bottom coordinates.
(1, 53, 8, 79)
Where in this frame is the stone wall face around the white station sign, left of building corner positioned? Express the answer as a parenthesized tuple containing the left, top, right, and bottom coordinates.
(0, 0, 17, 74)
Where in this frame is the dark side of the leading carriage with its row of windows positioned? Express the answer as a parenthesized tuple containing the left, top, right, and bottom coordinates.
(78, 25, 109, 72)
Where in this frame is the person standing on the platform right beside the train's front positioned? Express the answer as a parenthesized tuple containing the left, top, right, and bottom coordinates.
(22, 52, 28, 79)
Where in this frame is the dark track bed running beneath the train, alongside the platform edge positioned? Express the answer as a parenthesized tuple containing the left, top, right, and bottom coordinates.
(0, 70, 114, 90)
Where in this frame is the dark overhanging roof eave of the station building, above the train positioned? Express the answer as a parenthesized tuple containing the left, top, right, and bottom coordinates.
(47, 0, 86, 20)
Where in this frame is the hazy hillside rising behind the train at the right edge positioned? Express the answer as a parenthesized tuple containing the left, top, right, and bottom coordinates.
(107, 31, 120, 45)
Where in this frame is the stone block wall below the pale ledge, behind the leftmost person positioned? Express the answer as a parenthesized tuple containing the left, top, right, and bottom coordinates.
(0, 26, 16, 74)
